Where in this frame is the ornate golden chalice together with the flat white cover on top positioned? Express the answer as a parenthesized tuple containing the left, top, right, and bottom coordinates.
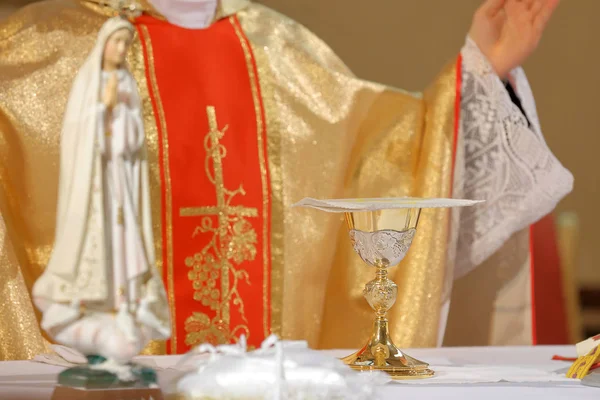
(294, 198, 480, 379)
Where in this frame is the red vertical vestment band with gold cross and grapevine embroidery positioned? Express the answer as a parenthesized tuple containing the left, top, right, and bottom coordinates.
(137, 16, 270, 353)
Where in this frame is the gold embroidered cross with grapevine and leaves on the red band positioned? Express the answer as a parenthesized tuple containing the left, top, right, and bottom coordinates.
(179, 106, 258, 346)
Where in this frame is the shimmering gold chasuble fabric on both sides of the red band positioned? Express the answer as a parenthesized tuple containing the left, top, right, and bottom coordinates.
(0, 0, 456, 360)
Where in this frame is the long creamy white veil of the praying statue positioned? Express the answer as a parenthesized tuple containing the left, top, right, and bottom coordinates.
(33, 17, 155, 301)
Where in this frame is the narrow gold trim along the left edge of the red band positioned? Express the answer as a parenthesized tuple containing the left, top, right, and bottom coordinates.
(140, 25, 177, 354)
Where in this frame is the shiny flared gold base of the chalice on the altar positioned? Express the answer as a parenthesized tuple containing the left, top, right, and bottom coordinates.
(342, 343, 435, 380)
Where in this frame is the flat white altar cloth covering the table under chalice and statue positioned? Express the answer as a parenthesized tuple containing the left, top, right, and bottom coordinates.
(0, 346, 600, 400)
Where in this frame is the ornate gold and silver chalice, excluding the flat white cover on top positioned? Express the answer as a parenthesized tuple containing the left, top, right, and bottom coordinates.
(342, 208, 434, 379)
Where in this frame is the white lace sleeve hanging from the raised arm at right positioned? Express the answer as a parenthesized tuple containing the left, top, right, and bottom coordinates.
(455, 39, 573, 278)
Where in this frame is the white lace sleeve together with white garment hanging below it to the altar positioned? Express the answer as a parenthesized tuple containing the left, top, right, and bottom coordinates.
(438, 39, 573, 346)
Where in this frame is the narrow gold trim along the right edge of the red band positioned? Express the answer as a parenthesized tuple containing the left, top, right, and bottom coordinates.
(229, 16, 270, 337)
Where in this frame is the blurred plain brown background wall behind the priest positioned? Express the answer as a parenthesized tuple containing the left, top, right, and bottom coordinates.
(0, 0, 600, 336)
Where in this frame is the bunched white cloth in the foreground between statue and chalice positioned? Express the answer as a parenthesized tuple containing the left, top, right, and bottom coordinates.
(167, 337, 389, 400)
